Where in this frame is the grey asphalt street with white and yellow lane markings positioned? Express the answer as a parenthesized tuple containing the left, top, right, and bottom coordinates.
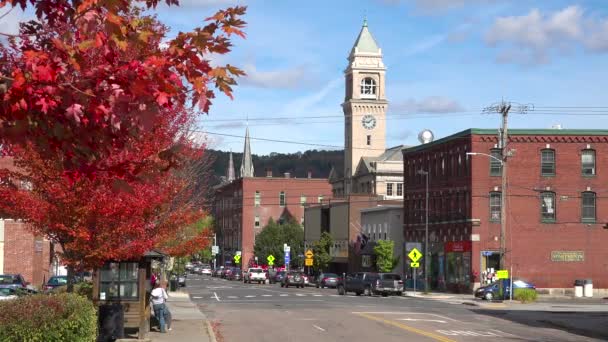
(186, 275, 607, 342)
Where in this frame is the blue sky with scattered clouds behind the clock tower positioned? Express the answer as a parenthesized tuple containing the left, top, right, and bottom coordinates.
(0, 0, 608, 154)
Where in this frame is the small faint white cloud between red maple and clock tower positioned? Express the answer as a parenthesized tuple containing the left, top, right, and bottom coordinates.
(239, 64, 311, 89)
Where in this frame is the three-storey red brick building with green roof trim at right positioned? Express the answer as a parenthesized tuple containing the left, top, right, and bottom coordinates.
(403, 129, 608, 292)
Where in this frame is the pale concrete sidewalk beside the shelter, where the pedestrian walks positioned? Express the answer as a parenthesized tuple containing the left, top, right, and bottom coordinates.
(149, 292, 215, 342)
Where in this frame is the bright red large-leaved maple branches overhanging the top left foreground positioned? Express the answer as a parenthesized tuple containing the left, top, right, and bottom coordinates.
(0, 0, 245, 177)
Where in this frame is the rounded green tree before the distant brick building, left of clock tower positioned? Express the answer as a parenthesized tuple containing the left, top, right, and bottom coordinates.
(253, 218, 304, 266)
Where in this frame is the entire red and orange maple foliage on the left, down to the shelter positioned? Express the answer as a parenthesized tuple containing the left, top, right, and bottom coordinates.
(0, 0, 245, 284)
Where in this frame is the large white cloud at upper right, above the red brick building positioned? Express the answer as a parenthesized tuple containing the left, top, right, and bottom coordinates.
(485, 6, 608, 65)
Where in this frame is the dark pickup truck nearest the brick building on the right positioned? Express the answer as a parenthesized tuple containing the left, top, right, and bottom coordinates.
(337, 272, 403, 296)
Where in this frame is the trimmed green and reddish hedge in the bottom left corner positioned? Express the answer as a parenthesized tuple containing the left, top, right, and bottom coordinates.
(0, 293, 97, 342)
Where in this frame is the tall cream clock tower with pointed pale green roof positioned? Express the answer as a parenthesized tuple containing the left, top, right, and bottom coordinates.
(342, 20, 388, 193)
